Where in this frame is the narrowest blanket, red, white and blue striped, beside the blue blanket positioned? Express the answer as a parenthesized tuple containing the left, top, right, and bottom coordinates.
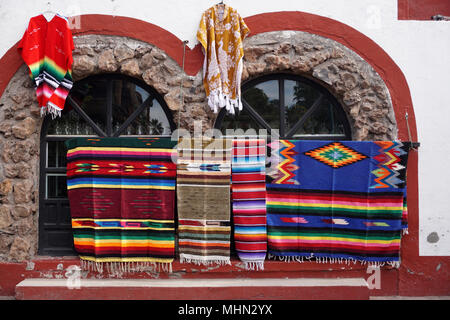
(231, 139, 267, 270)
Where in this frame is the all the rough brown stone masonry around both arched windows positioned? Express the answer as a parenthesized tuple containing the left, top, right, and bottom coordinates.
(0, 31, 397, 261)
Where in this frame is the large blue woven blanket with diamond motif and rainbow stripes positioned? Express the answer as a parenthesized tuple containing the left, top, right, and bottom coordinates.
(267, 140, 410, 266)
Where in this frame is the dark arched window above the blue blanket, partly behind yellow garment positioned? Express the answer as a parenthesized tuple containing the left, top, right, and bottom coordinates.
(215, 74, 351, 140)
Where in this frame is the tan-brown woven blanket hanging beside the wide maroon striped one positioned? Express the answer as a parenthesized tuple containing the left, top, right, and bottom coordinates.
(177, 139, 231, 265)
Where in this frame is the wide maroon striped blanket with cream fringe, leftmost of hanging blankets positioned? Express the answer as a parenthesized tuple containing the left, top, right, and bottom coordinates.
(66, 138, 176, 272)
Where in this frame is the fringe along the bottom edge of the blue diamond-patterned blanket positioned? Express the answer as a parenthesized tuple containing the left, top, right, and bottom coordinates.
(268, 253, 400, 269)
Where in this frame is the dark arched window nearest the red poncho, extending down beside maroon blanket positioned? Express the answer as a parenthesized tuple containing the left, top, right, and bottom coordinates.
(39, 75, 175, 256)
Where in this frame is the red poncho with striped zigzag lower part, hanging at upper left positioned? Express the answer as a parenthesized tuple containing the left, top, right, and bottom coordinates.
(18, 14, 74, 118)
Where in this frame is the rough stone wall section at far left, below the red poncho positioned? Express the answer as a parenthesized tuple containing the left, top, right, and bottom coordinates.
(0, 66, 42, 261)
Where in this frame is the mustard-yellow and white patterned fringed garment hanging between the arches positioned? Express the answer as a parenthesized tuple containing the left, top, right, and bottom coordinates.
(197, 4, 250, 114)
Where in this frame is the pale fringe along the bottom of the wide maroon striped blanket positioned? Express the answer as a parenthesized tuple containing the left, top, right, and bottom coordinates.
(80, 259, 172, 274)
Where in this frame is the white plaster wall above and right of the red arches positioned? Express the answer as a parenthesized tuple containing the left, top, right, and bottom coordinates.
(0, 0, 450, 256)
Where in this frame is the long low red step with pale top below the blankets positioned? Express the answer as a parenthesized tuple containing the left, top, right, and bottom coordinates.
(16, 278, 369, 300)
